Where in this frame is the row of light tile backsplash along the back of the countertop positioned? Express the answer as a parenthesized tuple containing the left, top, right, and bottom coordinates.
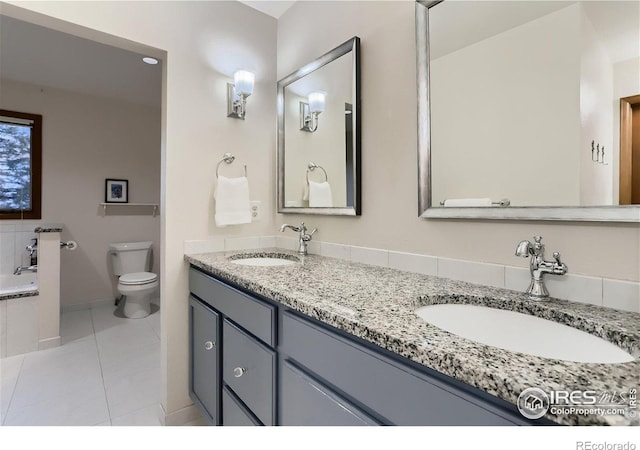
(185, 235, 640, 313)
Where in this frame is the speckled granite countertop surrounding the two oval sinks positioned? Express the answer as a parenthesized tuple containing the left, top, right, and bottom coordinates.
(185, 249, 640, 425)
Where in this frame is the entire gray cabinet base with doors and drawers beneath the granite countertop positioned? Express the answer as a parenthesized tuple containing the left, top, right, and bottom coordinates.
(189, 267, 550, 426)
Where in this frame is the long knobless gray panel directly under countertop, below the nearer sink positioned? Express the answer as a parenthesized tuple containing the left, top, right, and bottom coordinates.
(281, 312, 514, 425)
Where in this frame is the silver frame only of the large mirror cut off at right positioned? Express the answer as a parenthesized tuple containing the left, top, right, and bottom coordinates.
(415, 0, 640, 222)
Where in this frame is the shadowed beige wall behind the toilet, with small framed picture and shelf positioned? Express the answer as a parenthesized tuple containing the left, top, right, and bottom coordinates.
(0, 80, 161, 306)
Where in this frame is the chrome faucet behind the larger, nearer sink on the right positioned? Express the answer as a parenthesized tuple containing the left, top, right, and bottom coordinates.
(516, 236, 568, 300)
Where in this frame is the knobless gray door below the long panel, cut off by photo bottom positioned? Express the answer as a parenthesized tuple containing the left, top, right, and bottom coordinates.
(280, 360, 378, 426)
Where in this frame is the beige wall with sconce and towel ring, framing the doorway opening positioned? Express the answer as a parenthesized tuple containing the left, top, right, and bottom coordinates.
(2, 1, 276, 415)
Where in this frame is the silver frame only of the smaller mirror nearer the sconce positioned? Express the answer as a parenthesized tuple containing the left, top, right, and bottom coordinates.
(276, 36, 361, 216)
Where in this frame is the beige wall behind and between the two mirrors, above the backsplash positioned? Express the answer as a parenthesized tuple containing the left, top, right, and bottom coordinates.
(277, 2, 640, 281)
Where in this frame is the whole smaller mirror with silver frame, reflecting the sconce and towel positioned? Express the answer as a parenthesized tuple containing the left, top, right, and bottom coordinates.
(277, 37, 361, 216)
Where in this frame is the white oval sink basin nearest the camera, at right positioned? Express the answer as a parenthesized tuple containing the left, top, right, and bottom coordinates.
(415, 303, 635, 364)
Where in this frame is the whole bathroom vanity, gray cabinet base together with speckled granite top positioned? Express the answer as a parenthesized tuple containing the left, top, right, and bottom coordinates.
(185, 250, 640, 426)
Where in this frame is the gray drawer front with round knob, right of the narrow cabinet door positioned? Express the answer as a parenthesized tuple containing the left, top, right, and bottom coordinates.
(222, 319, 276, 425)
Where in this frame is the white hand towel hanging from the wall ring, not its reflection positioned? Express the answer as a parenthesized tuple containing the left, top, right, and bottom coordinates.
(215, 176, 251, 227)
